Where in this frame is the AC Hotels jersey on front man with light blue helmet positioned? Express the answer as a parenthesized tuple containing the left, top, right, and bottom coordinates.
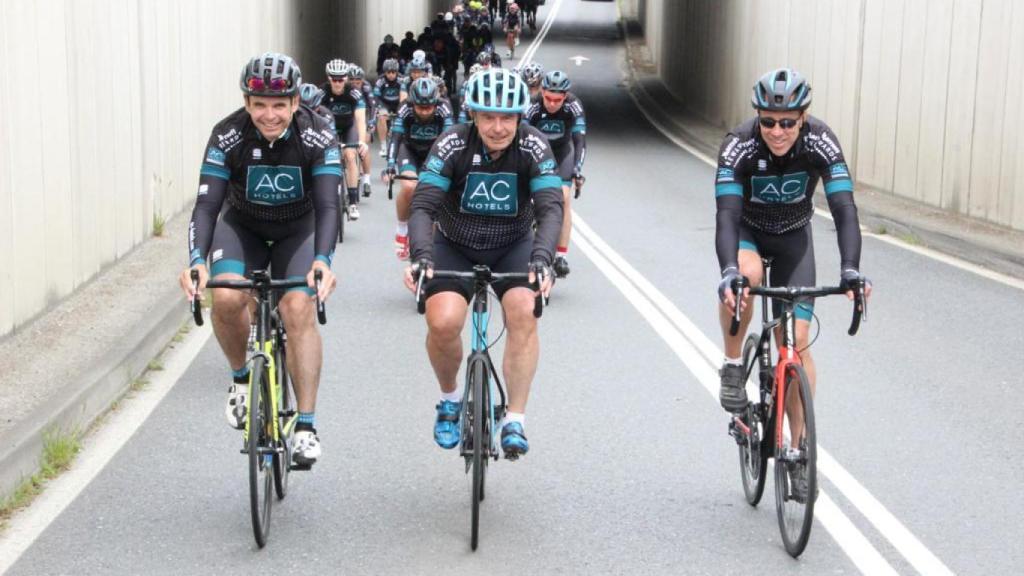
(409, 124, 563, 264)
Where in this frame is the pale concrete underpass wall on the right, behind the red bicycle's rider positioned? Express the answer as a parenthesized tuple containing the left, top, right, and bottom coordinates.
(625, 0, 1024, 230)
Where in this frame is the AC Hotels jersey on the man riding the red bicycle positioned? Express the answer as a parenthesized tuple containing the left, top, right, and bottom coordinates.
(715, 115, 860, 270)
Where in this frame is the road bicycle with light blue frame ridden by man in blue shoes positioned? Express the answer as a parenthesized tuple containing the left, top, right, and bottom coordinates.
(416, 264, 544, 550)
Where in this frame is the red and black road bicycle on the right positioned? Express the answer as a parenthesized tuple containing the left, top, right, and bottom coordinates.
(729, 258, 867, 558)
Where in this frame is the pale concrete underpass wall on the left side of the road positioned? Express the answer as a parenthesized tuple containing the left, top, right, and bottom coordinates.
(0, 0, 447, 337)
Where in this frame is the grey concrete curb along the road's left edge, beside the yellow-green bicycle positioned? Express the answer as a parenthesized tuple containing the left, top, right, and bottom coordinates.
(0, 286, 188, 496)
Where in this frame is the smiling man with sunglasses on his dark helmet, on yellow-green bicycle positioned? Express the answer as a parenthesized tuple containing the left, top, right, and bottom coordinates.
(179, 52, 341, 464)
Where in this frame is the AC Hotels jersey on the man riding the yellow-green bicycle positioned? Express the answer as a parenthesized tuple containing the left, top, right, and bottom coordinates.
(188, 106, 341, 265)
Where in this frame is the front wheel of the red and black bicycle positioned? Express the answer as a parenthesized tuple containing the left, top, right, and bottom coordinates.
(775, 365, 818, 558)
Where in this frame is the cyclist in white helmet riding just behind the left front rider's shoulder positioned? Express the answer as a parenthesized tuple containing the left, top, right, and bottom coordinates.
(324, 58, 368, 220)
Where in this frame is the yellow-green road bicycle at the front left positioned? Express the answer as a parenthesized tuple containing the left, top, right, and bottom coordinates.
(190, 270, 327, 548)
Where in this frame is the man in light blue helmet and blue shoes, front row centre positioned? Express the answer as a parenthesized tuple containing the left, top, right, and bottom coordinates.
(406, 69, 562, 456)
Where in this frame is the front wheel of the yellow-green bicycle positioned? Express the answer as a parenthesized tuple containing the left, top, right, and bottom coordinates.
(246, 357, 273, 548)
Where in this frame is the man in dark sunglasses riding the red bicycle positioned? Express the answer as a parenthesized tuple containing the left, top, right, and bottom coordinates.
(715, 68, 870, 412)
